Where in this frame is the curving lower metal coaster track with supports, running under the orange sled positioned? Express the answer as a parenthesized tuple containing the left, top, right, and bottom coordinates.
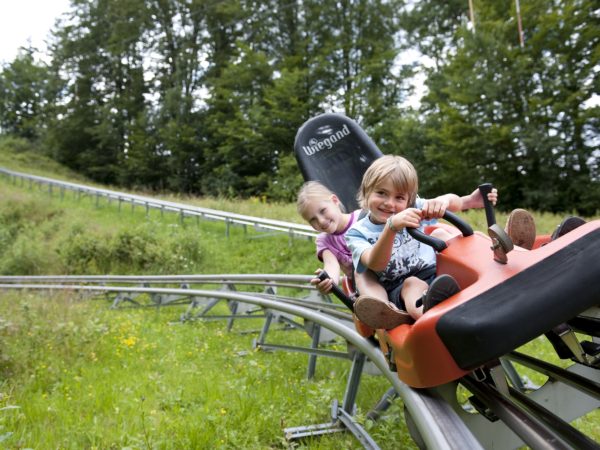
(0, 274, 600, 449)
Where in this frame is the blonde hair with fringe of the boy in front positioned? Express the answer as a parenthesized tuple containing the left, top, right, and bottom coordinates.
(357, 155, 419, 209)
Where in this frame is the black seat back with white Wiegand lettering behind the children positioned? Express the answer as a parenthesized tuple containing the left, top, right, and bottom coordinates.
(294, 113, 382, 212)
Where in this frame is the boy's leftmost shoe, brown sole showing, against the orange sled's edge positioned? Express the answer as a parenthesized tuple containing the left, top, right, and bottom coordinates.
(354, 295, 414, 330)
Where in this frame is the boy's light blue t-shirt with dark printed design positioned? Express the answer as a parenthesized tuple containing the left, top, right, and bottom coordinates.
(346, 198, 435, 289)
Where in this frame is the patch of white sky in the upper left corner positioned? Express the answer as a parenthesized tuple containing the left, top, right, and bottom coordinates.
(0, 0, 69, 64)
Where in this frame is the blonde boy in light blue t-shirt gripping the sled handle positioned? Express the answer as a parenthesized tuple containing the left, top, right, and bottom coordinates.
(346, 155, 497, 329)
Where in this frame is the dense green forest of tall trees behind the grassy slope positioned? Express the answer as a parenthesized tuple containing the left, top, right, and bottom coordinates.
(0, 0, 600, 216)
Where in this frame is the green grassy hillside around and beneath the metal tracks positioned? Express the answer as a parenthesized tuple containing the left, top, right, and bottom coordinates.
(0, 140, 600, 449)
